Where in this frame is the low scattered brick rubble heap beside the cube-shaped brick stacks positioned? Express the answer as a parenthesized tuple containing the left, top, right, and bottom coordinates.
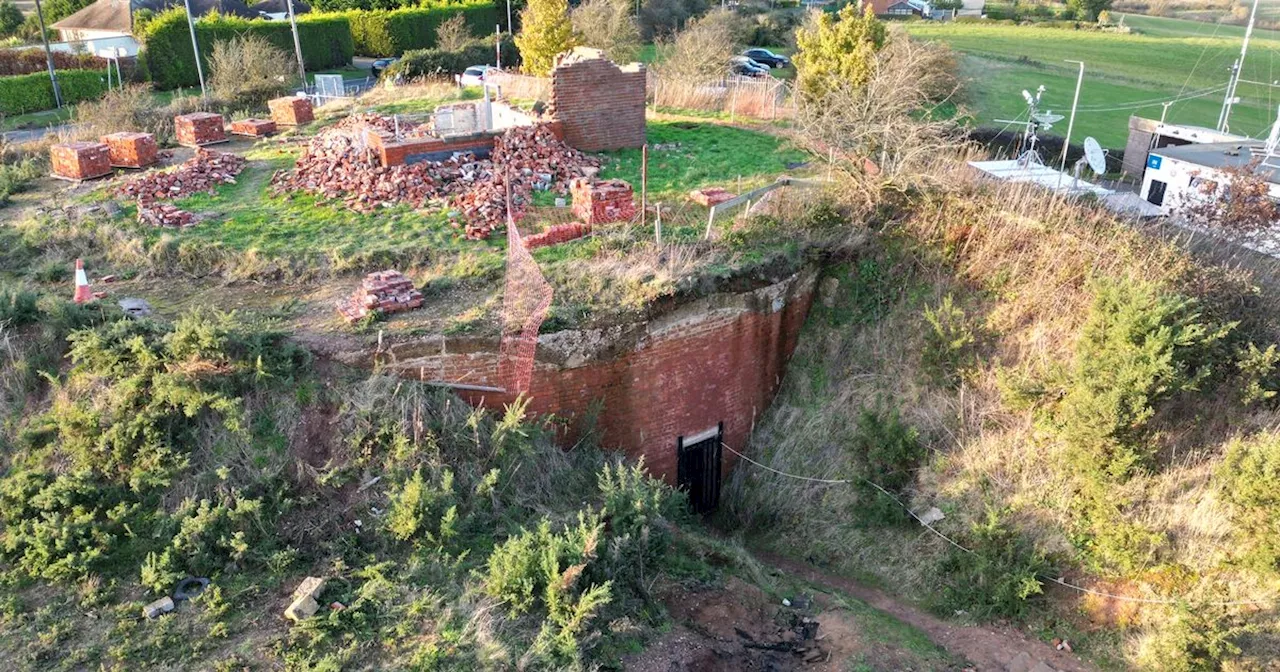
(115, 148, 246, 228)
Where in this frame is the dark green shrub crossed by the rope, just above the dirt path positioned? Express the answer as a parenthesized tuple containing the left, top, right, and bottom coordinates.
(938, 511, 1050, 620)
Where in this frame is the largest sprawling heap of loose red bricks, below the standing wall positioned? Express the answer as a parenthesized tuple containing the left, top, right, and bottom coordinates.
(271, 115, 599, 239)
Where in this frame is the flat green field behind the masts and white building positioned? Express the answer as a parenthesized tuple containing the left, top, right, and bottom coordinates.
(906, 15, 1280, 148)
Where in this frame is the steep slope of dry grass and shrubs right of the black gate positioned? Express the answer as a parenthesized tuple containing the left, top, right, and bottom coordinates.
(727, 179, 1280, 671)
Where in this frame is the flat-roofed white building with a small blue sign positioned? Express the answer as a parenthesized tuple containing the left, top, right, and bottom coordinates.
(1139, 141, 1280, 215)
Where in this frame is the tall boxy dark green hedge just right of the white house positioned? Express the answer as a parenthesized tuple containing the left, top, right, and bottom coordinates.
(140, 8, 353, 88)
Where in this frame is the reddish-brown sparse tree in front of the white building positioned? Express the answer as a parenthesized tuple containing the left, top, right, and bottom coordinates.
(1175, 159, 1280, 234)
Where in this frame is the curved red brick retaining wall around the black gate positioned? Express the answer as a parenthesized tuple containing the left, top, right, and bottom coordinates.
(345, 271, 817, 483)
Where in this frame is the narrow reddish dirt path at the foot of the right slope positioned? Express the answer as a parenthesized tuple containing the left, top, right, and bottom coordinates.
(755, 552, 1097, 672)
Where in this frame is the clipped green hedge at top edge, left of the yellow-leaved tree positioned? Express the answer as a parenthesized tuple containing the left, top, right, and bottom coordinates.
(344, 1, 507, 56)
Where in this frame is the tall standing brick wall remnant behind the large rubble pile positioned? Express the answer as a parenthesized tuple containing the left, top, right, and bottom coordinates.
(552, 47, 645, 151)
